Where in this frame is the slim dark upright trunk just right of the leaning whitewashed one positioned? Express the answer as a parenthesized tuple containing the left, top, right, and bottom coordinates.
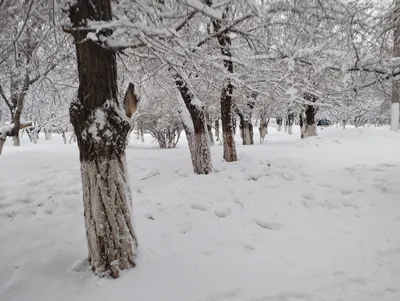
(212, 11, 238, 162)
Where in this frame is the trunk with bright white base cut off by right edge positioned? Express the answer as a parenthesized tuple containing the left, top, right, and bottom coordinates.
(390, 0, 400, 132)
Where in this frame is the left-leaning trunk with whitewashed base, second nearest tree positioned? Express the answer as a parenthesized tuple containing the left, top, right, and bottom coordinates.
(175, 75, 212, 174)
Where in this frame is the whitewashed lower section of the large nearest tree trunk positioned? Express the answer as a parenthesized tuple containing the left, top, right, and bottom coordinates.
(81, 156, 137, 278)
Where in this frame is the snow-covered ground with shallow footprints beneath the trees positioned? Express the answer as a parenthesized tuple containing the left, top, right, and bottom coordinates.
(0, 127, 400, 301)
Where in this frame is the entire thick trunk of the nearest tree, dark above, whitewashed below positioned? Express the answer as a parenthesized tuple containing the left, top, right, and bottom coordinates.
(69, 0, 138, 278)
